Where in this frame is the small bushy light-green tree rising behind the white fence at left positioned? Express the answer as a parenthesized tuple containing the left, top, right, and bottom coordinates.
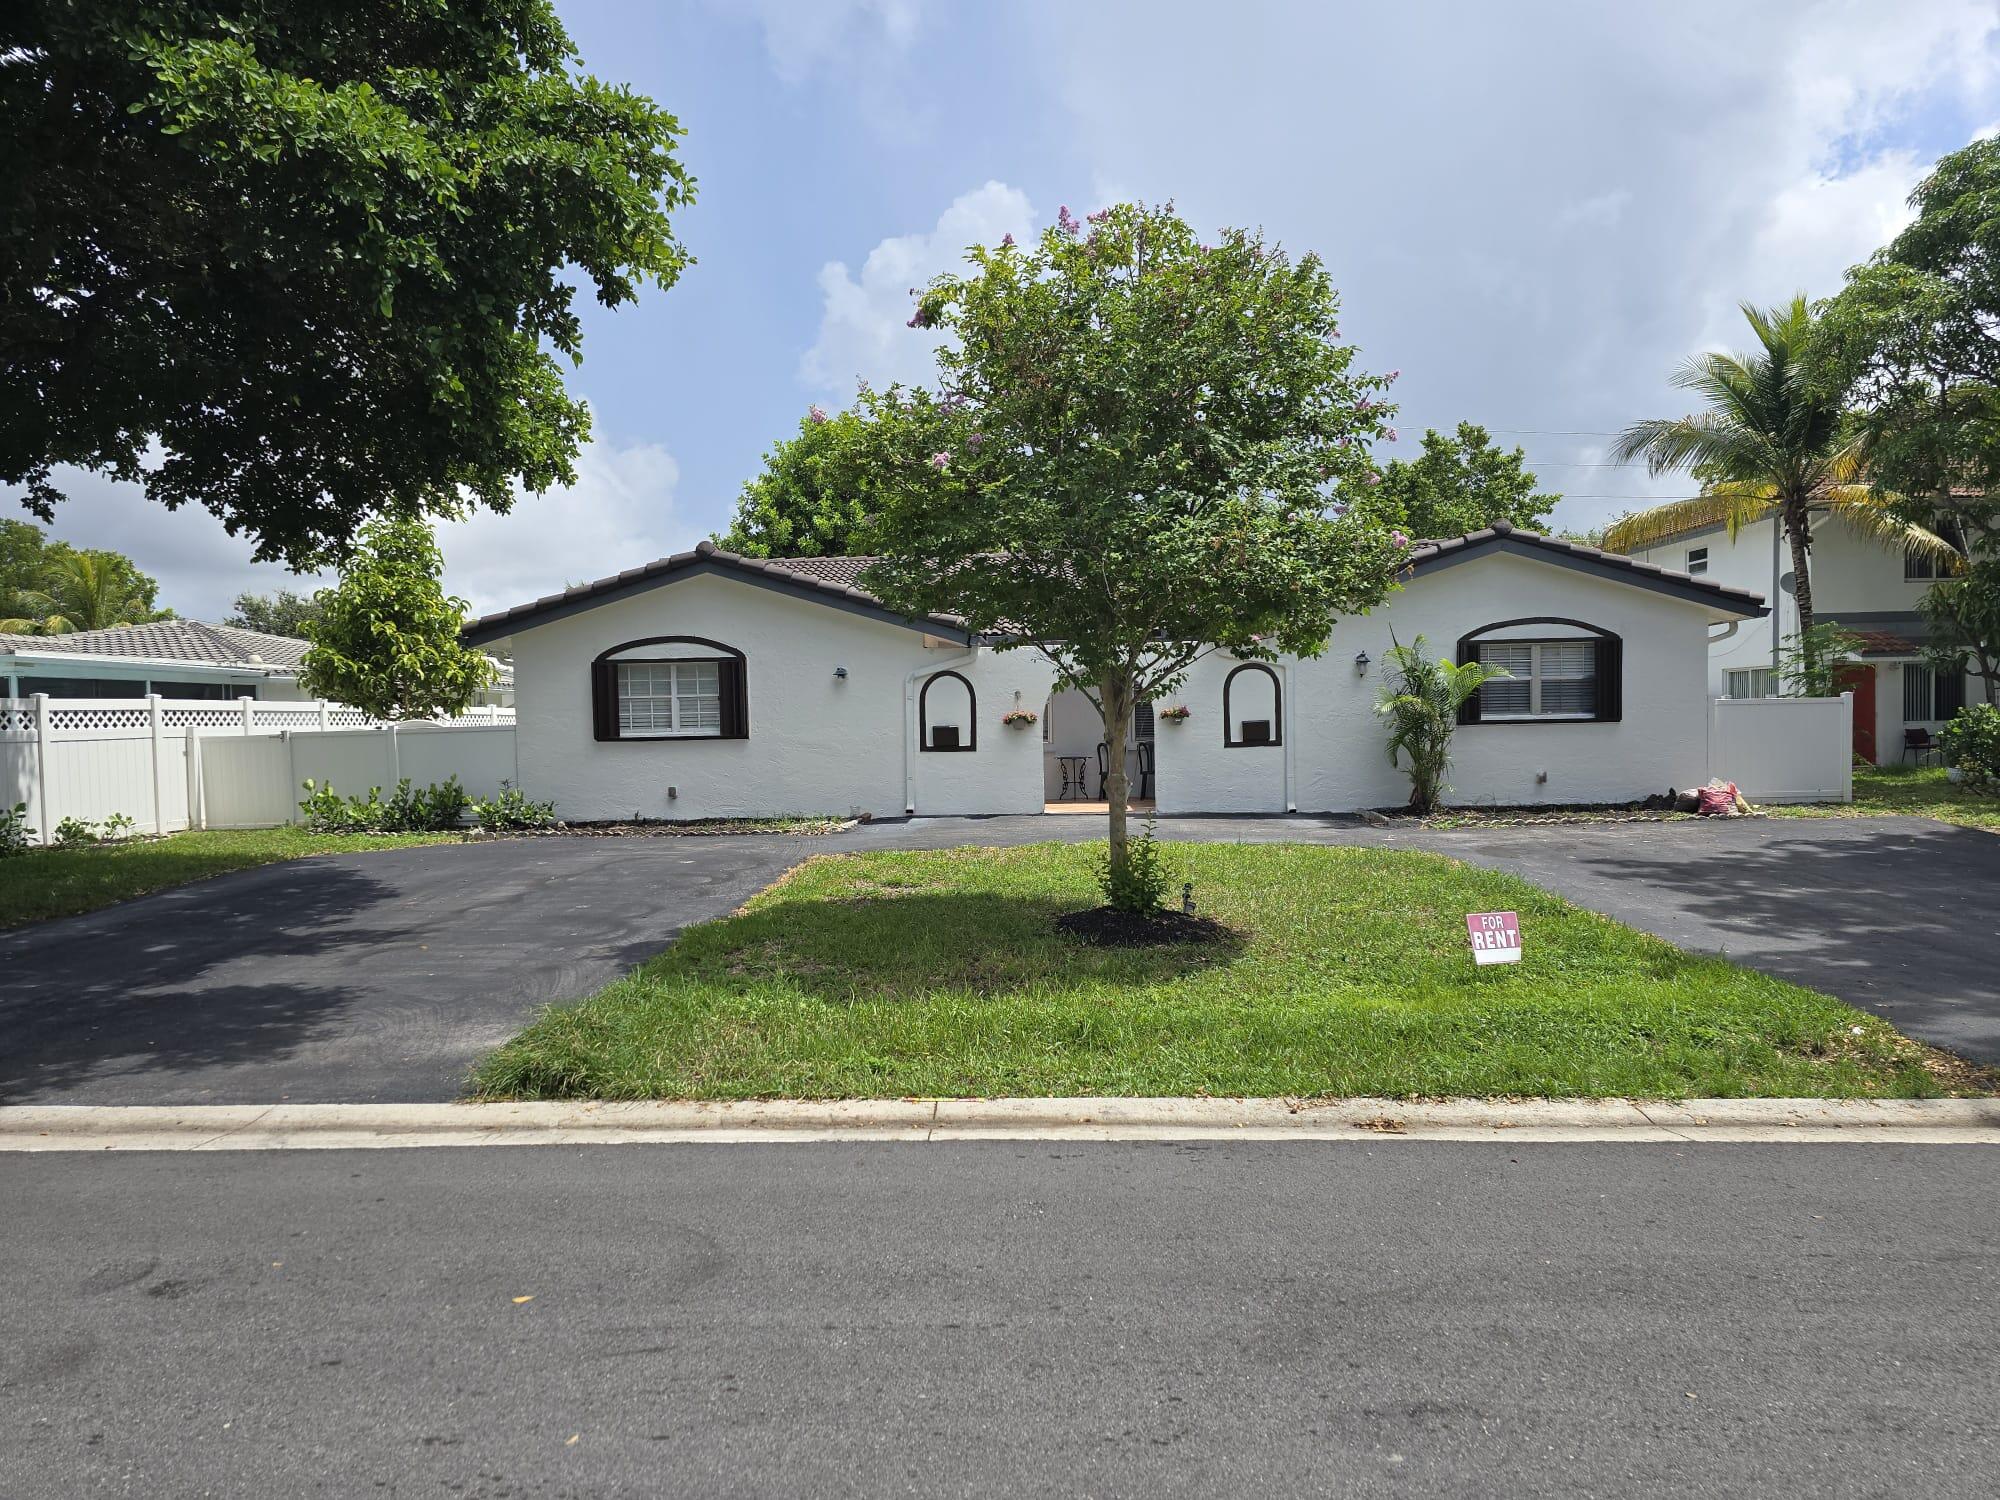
(298, 518, 492, 720)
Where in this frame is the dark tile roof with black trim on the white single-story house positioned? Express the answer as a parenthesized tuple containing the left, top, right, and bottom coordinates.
(466, 522, 1768, 642)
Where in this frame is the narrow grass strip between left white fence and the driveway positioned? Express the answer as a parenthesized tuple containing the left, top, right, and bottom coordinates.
(0, 828, 462, 928)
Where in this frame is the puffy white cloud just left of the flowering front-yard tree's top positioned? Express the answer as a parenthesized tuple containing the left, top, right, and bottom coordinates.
(798, 182, 1034, 396)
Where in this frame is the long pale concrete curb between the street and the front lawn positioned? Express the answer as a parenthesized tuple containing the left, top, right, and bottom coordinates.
(11, 1098, 2000, 1152)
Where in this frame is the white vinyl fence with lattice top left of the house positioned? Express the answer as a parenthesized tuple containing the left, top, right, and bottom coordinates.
(0, 694, 514, 844)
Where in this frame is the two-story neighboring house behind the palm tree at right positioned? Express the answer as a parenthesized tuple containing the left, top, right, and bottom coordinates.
(1632, 516, 1978, 764)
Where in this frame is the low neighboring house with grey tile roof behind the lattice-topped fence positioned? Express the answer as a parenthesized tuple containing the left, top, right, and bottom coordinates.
(0, 620, 514, 708)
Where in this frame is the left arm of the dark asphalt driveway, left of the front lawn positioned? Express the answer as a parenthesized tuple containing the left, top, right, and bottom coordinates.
(0, 836, 826, 1104)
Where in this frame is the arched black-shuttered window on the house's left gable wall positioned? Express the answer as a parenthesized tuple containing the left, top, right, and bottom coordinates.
(590, 636, 750, 740)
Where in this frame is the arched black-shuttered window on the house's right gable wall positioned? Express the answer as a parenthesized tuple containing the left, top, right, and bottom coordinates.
(1458, 614, 1624, 724)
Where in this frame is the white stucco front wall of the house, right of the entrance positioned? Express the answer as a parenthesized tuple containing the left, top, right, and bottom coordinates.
(1158, 554, 1708, 812)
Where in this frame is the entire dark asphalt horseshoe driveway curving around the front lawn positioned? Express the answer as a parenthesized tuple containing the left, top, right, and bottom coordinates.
(0, 818, 2000, 1104)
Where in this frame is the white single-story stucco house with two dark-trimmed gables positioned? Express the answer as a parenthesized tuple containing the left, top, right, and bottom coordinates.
(466, 526, 1764, 820)
